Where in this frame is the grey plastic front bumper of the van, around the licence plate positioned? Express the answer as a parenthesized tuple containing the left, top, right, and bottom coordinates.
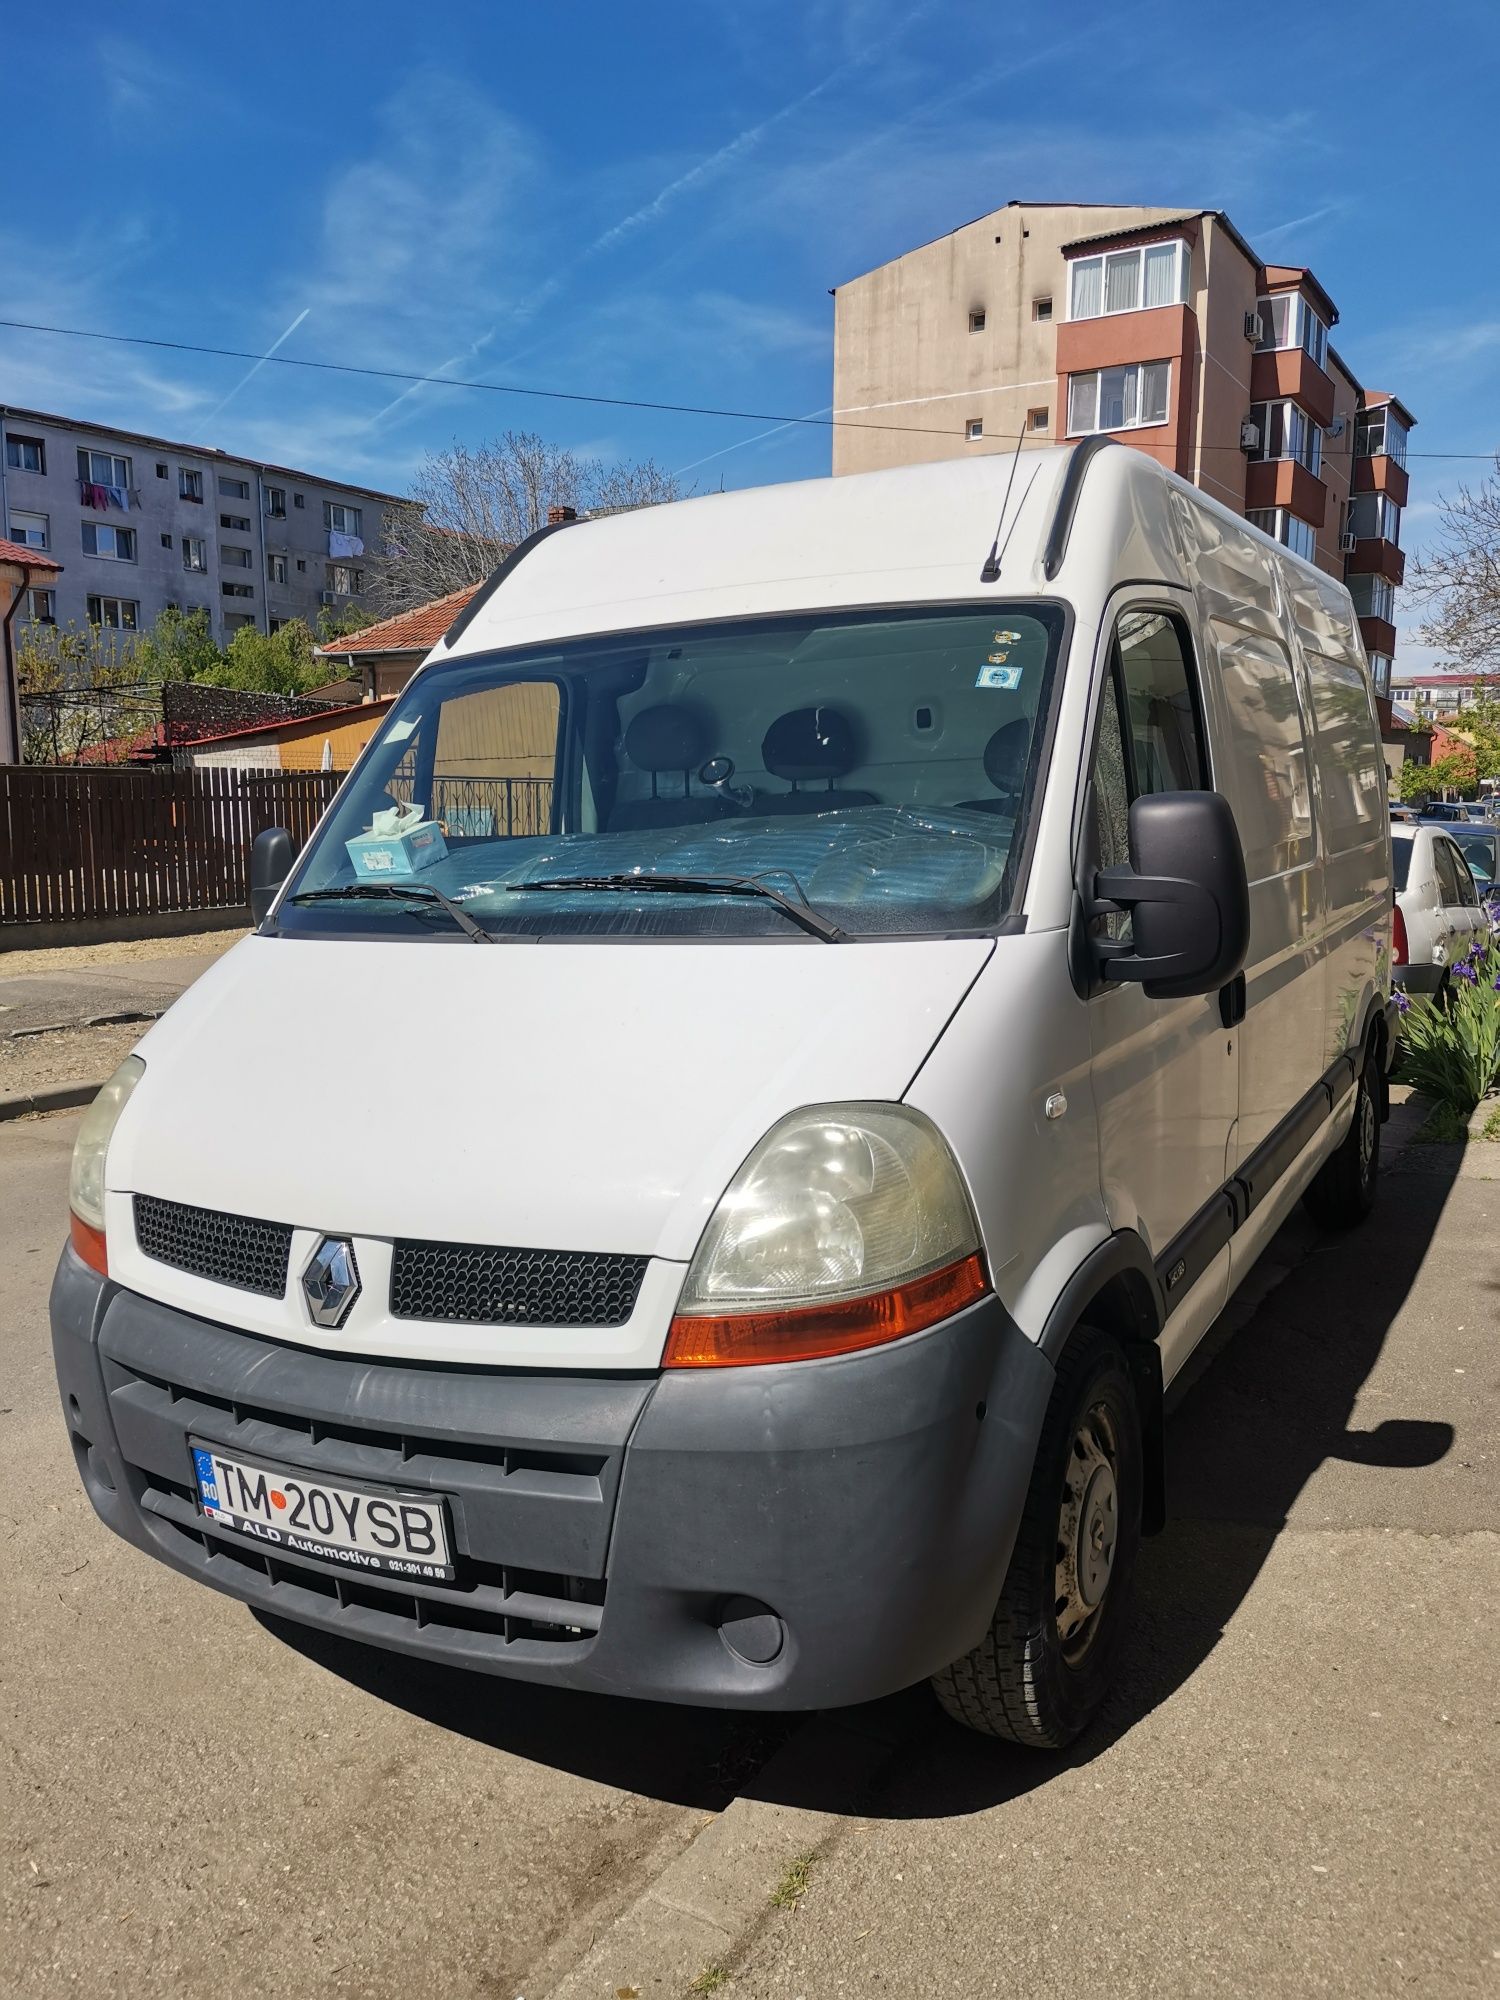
(52, 1250, 1054, 1708)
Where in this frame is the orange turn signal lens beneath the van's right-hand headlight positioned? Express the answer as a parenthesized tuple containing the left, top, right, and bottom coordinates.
(662, 1256, 990, 1368)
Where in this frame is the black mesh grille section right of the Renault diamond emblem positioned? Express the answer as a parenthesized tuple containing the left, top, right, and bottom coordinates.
(390, 1240, 646, 1326)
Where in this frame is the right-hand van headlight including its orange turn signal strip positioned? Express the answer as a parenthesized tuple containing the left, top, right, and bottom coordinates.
(664, 1104, 990, 1368)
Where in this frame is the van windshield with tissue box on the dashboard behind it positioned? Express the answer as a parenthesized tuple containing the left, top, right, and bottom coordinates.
(276, 602, 1064, 944)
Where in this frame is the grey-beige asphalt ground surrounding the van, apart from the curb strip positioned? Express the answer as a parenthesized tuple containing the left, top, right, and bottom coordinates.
(0, 1116, 1500, 2000)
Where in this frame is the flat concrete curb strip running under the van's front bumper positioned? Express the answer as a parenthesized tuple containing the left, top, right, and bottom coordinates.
(546, 1710, 904, 2000)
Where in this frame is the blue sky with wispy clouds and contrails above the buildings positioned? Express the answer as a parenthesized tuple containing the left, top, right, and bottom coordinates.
(0, 0, 1500, 658)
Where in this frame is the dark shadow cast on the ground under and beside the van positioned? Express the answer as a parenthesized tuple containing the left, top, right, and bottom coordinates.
(262, 1148, 1456, 1818)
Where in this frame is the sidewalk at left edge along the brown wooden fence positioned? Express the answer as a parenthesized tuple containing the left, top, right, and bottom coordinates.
(0, 930, 244, 1102)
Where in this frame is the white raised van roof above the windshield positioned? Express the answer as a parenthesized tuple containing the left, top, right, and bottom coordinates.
(430, 440, 1360, 664)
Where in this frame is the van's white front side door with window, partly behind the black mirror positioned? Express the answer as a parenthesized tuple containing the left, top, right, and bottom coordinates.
(1082, 596, 1238, 1378)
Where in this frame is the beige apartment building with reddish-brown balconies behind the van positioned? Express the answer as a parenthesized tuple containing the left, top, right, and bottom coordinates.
(834, 202, 1416, 704)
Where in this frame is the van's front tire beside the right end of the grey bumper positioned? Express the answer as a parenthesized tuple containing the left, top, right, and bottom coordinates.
(932, 1326, 1144, 1750)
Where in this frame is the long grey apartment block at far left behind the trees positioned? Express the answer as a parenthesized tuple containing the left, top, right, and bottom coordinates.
(0, 406, 408, 642)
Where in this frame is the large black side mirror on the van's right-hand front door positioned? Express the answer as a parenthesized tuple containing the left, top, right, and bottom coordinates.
(1090, 792, 1250, 1000)
